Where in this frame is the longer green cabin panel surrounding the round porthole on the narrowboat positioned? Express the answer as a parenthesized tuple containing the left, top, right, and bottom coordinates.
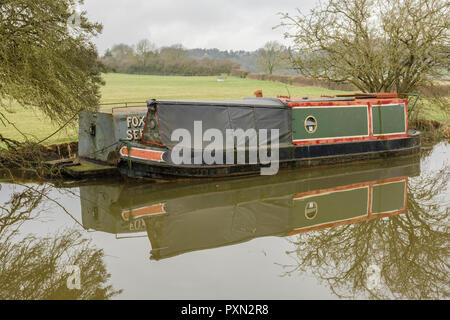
(292, 106, 369, 140)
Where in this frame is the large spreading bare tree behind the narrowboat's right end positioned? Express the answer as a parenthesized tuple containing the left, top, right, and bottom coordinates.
(281, 0, 450, 93)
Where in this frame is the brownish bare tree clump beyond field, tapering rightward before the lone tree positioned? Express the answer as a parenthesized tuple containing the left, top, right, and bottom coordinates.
(101, 40, 240, 76)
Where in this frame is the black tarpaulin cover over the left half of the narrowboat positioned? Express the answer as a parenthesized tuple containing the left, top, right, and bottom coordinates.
(153, 98, 292, 148)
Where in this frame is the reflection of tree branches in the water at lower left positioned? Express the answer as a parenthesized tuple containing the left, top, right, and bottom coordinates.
(0, 187, 121, 300)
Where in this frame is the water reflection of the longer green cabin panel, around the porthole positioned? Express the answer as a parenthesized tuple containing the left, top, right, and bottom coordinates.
(292, 187, 369, 228)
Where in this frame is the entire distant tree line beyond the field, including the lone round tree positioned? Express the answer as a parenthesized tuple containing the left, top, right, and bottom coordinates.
(102, 39, 297, 75)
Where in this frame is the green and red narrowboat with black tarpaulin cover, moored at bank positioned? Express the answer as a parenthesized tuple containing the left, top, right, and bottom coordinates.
(118, 93, 420, 179)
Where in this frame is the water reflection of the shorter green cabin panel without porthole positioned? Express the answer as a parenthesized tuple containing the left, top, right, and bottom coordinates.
(372, 181, 406, 213)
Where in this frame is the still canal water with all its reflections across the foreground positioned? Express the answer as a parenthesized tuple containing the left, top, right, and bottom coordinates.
(0, 142, 450, 299)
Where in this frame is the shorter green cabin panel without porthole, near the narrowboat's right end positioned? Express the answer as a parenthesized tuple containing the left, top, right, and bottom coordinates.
(372, 104, 405, 135)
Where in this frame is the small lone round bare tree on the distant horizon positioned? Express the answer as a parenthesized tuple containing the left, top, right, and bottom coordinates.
(256, 41, 287, 74)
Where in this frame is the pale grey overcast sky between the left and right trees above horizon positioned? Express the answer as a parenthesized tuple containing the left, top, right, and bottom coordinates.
(83, 0, 316, 53)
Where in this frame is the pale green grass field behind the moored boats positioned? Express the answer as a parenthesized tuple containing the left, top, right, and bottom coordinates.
(0, 74, 442, 144)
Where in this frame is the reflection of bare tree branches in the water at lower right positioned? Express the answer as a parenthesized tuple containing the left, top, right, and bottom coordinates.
(283, 166, 450, 299)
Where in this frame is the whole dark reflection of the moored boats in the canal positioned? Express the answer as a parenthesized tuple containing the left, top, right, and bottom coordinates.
(80, 158, 420, 260)
